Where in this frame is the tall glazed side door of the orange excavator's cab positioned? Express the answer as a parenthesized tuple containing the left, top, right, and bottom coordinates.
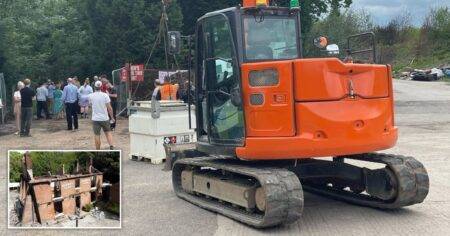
(197, 14, 244, 145)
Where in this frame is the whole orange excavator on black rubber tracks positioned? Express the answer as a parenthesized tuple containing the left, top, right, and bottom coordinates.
(172, 0, 429, 228)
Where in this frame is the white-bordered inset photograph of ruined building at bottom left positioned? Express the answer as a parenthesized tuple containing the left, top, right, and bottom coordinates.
(8, 150, 121, 228)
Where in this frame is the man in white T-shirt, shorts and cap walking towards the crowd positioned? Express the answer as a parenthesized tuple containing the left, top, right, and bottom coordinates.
(88, 81, 115, 150)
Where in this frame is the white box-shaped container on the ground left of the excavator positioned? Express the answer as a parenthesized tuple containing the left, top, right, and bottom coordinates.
(129, 100, 197, 164)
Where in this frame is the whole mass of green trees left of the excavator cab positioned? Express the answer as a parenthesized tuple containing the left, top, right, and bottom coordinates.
(0, 0, 182, 110)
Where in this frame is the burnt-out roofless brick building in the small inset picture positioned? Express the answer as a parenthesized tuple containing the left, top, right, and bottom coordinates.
(18, 153, 103, 224)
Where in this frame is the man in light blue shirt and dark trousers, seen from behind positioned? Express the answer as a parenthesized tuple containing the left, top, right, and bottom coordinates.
(62, 78, 78, 130)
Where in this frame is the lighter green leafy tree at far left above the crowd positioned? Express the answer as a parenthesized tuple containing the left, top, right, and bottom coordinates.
(0, 0, 95, 106)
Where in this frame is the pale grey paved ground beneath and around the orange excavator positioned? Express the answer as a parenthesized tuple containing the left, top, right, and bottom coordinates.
(0, 81, 450, 235)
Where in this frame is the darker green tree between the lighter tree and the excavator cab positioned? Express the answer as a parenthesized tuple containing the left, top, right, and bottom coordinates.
(78, 0, 182, 73)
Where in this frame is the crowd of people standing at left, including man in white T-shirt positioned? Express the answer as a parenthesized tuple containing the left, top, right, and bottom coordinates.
(14, 75, 117, 149)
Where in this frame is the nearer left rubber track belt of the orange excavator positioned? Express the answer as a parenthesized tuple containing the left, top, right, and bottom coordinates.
(172, 156, 303, 228)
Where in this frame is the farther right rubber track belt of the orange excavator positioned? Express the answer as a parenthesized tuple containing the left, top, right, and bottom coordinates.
(302, 153, 429, 209)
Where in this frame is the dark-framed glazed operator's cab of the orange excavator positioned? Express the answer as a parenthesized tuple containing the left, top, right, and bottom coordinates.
(194, 7, 301, 155)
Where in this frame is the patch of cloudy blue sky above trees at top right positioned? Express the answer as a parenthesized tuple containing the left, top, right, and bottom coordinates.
(351, 0, 450, 26)
